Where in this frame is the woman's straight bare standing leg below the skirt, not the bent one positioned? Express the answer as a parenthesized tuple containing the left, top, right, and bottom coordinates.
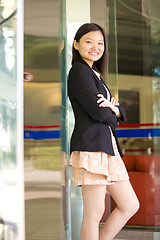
(81, 185, 106, 240)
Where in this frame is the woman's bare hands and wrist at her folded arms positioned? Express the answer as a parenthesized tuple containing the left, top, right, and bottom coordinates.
(97, 94, 121, 117)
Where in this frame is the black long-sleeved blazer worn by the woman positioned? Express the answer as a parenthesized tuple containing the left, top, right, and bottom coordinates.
(68, 62, 125, 156)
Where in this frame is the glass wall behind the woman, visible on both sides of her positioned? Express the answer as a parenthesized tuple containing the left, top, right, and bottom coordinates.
(66, 0, 160, 239)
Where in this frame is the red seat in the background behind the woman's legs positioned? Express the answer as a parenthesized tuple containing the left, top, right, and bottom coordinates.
(101, 154, 160, 226)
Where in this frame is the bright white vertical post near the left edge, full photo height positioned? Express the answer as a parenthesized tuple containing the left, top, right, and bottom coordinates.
(16, 0, 25, 240)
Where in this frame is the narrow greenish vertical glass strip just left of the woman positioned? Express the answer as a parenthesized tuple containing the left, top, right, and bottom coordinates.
(60, 0, 72, 240)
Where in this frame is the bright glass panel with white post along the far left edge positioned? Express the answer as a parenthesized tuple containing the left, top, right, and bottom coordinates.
(0, 0, 24, 240)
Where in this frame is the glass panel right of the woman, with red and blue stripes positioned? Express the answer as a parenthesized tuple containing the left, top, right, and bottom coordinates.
(111, 0, 160, 239)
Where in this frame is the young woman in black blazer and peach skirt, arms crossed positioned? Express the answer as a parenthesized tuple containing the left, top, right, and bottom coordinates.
(68, 23, 139, 240)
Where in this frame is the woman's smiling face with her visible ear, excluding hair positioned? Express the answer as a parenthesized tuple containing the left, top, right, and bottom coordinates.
(74, 31, 104, 68)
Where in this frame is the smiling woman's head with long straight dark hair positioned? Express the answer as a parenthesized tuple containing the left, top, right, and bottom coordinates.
(72, 23, 108, 75)
